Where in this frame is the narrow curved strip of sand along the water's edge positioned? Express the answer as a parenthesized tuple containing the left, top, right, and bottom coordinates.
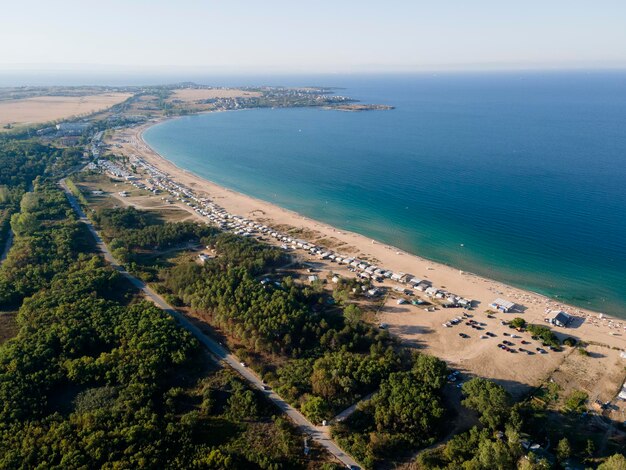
(108, 111, 626, 349)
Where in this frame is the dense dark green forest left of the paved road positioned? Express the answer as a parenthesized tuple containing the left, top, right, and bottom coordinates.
(0, 139, 332, 469)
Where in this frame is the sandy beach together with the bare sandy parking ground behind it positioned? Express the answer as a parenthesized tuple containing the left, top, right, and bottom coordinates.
(108, 117, 626, 399)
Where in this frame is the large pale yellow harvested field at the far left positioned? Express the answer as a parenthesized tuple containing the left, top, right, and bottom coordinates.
(0, 93, 132, 128)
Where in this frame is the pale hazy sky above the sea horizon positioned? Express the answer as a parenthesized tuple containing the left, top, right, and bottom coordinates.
(0, 0, 626, 73)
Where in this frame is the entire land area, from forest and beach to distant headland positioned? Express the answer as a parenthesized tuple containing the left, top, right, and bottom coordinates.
(0, 82, 626, 469)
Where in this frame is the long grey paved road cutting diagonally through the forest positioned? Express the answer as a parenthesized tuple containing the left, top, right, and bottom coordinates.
(60, 179, 360, 468)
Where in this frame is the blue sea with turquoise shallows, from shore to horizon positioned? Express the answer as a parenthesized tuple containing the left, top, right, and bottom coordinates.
(144, 72, 626, 317)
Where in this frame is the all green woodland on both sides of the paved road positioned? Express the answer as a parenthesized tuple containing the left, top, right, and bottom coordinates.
(0, 129, 626, 470)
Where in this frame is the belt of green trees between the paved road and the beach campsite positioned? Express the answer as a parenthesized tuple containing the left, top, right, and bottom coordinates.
(83, 204, 447, 467)
